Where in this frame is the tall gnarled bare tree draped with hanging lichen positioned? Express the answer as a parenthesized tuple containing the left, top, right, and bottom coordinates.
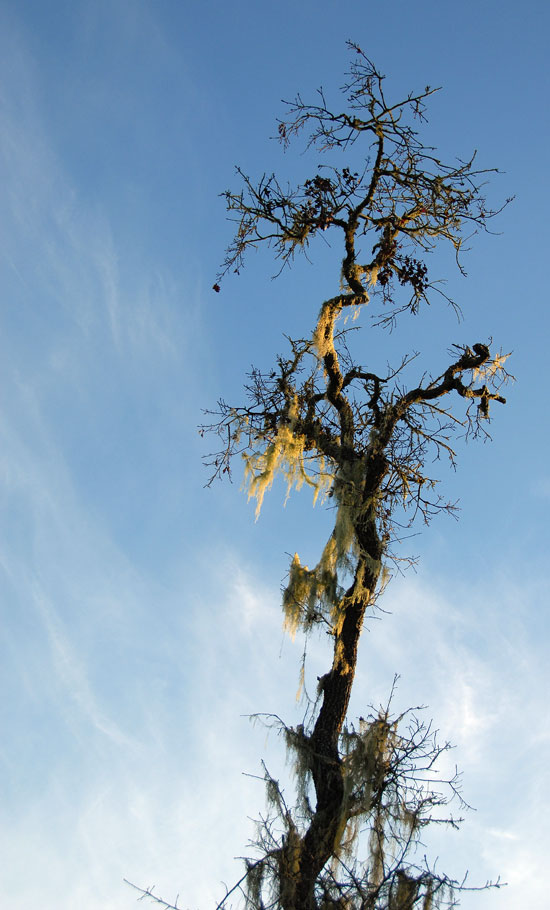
(130, 44, 508, 910)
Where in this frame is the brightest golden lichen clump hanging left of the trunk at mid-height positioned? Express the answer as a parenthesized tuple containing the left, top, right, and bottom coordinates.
(243, 396, 332, 519)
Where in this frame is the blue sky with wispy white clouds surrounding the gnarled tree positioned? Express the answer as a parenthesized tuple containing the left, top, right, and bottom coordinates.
(0, 0, 550, 910)
